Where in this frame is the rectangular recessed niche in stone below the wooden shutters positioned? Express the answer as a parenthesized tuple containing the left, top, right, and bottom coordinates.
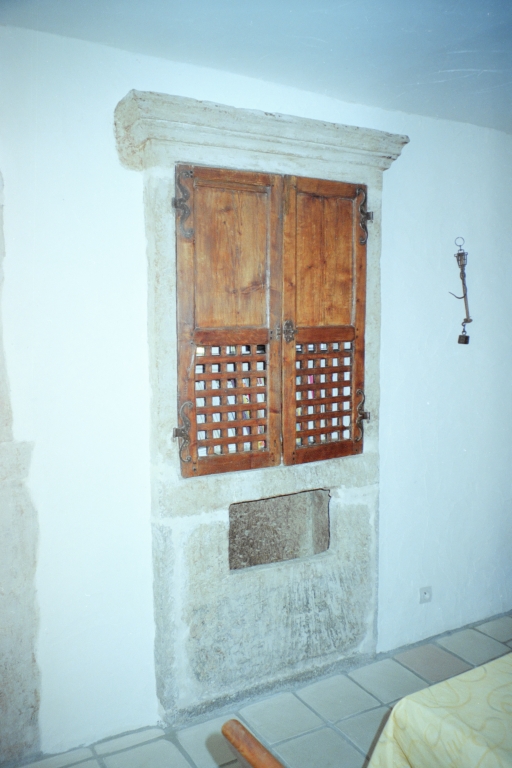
(229, 489, 330, 570)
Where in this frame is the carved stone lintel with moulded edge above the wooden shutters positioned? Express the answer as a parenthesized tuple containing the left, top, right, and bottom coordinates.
(115, 91, 409, 173)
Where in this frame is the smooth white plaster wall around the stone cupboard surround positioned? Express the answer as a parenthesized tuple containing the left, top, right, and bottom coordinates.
(0, 28, 512, 751)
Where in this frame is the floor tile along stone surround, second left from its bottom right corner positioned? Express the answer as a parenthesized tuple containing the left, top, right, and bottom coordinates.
(296, 675, 380, 723)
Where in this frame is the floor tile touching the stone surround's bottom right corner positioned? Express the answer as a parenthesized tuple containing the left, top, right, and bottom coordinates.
(349, 659, 427, 704)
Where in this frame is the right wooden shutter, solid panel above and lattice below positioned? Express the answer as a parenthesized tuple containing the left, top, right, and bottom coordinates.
(282, 176, 367, 464)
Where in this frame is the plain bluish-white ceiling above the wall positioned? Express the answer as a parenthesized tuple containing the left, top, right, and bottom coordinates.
(0, 0, 512, 133)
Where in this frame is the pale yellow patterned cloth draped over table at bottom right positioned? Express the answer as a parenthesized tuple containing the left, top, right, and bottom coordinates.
(368, 654, 512, 768)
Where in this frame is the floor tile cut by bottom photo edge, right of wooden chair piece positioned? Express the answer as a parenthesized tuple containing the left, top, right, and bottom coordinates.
(273, 728, 365, 768)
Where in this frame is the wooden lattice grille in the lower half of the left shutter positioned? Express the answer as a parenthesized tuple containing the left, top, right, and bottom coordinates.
(194, 344, 268, 459)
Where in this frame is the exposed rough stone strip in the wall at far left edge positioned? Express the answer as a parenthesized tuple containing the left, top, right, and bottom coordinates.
(0, 176, 40, 764)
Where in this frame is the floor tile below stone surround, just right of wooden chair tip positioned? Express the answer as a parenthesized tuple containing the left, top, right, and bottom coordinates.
(240, 693, 323, 744)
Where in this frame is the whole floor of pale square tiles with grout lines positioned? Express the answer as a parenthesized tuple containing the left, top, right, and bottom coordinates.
(17, 616, 512, 768)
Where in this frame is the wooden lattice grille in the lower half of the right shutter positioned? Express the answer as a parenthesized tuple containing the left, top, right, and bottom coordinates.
(295, 341, 353, 448)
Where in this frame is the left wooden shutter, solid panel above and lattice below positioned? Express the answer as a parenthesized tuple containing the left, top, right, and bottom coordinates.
(175, 165, 283, 477)
